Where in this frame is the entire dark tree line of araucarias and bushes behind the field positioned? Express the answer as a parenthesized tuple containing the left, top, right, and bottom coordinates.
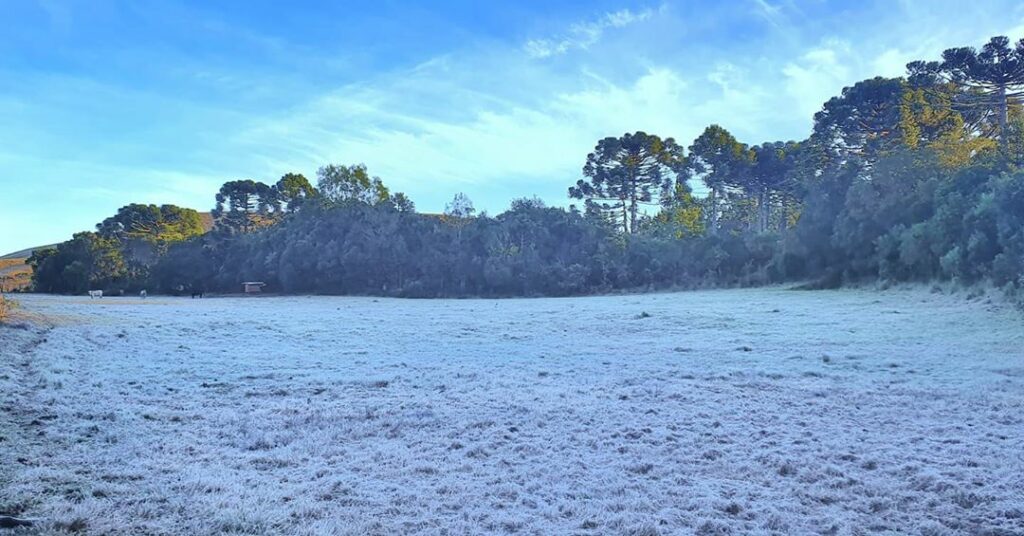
(24, 37, 1024, 297)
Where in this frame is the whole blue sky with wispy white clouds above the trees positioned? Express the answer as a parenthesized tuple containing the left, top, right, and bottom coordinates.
(0, 0, 1024, 253)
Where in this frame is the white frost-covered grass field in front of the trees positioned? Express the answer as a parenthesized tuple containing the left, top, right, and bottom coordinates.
(0, 289, 1024, 535)
